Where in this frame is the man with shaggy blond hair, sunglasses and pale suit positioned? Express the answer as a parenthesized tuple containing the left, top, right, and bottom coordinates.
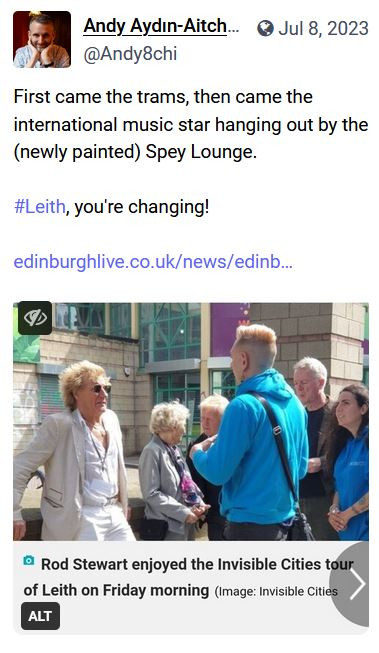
(13, 361, 135, 541)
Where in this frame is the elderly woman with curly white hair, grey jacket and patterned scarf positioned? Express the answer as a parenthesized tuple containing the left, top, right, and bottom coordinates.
(139, 401, 209, 540)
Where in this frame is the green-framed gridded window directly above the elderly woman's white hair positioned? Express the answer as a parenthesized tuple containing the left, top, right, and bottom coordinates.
(140, 303, 200, 367)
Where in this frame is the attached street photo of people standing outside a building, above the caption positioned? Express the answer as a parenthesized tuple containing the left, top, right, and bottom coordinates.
(13, 302, 369, 542)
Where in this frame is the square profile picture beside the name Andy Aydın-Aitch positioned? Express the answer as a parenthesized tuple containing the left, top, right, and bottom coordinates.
(13, 10, 71, 68)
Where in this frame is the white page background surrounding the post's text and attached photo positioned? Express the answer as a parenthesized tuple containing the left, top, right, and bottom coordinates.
(0, 1, 377, 651)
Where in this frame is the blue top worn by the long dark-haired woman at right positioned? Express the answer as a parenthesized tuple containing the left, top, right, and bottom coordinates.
(334, 426, 368, 540)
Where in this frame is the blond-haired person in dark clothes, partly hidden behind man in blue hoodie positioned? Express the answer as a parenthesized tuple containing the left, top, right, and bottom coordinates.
(186, 394, 229, 541)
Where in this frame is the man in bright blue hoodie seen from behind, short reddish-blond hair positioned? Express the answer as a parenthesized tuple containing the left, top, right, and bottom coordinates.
(191, 324, 308, 541)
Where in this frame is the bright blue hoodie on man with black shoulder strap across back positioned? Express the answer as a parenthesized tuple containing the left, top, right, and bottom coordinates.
(193, 369, 308, 524)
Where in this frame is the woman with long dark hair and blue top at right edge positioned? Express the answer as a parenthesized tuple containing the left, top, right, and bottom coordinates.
(328, 383, 369, 540)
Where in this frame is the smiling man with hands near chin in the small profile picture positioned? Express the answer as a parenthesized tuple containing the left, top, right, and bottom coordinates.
(13, 14, 70, 68)
